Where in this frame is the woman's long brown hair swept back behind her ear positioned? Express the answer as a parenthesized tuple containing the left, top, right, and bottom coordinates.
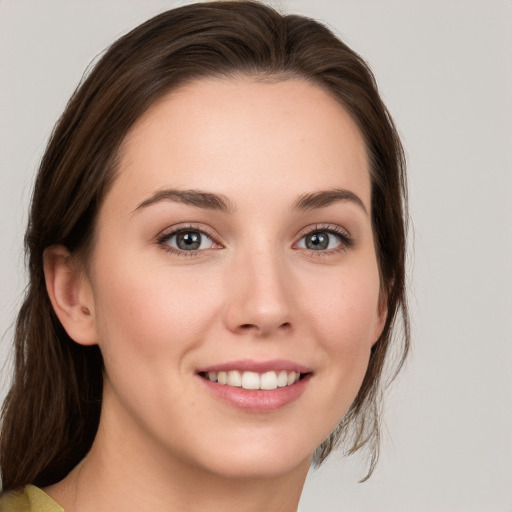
(0, 2, 409, 491)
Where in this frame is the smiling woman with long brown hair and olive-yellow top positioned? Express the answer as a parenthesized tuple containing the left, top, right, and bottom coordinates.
(0, 2, 408, 512)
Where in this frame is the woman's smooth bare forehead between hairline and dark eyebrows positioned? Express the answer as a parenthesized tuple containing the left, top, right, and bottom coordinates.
(112, 75, 370, 211)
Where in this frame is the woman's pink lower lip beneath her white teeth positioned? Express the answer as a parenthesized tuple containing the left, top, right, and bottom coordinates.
(198, 374, 311, 413)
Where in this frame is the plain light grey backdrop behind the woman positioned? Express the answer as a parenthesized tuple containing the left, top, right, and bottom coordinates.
(0, 0, 512, 512)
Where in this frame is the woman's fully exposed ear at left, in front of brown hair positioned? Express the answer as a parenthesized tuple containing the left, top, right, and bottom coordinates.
(43, 245, 97, 345)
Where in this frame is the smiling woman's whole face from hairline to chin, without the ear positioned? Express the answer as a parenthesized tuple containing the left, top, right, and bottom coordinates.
(82, 79, 385, 477)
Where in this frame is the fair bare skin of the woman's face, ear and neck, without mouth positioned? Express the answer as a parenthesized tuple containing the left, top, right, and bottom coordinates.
(45, 78, 386, 512)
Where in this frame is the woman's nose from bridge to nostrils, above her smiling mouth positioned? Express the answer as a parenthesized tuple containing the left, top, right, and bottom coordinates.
(225, 251, 292, 338)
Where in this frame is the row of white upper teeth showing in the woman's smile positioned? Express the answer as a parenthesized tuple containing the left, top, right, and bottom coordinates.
(206, 370, 300, 390)
